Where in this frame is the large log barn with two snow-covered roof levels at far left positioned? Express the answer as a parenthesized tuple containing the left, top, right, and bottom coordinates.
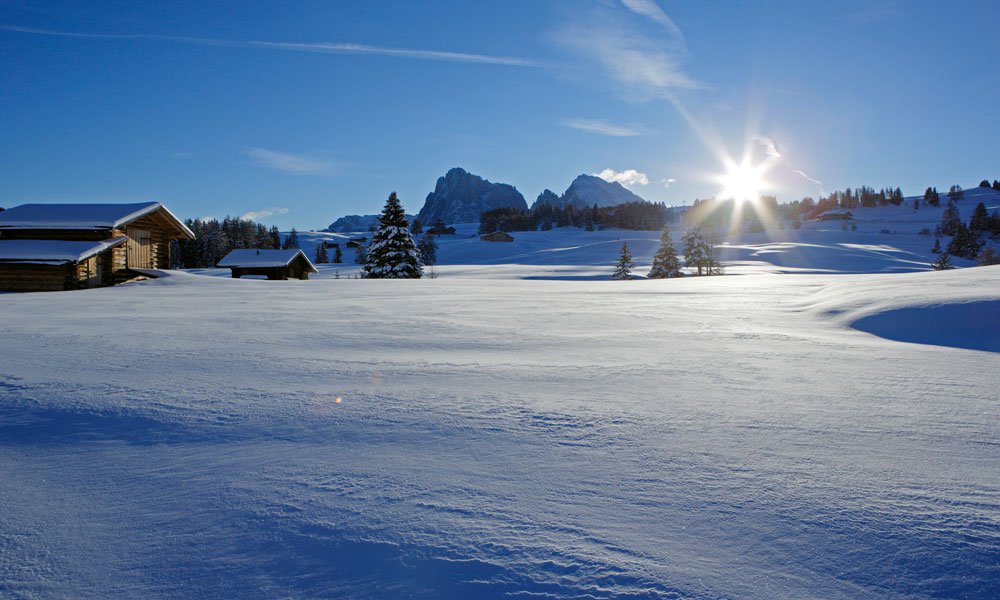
(0, 202, 194, 292)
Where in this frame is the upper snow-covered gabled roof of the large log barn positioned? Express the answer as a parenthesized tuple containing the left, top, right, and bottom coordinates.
(0, 202, 194, 238)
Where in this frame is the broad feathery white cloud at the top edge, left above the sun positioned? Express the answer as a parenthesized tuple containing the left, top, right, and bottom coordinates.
(555, 2, 701, 100)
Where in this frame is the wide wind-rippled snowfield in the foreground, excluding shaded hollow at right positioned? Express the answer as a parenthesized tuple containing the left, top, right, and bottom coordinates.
(0, 268, 1000, 598)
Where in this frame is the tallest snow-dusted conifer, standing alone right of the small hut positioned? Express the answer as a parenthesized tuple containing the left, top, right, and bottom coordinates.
(362, 192, 423, 279)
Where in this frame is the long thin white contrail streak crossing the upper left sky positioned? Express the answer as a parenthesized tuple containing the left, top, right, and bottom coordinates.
(0, 25, 540, 67)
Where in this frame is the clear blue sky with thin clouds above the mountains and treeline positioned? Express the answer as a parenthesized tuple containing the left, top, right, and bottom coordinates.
(0, 0, 1000, 229)
